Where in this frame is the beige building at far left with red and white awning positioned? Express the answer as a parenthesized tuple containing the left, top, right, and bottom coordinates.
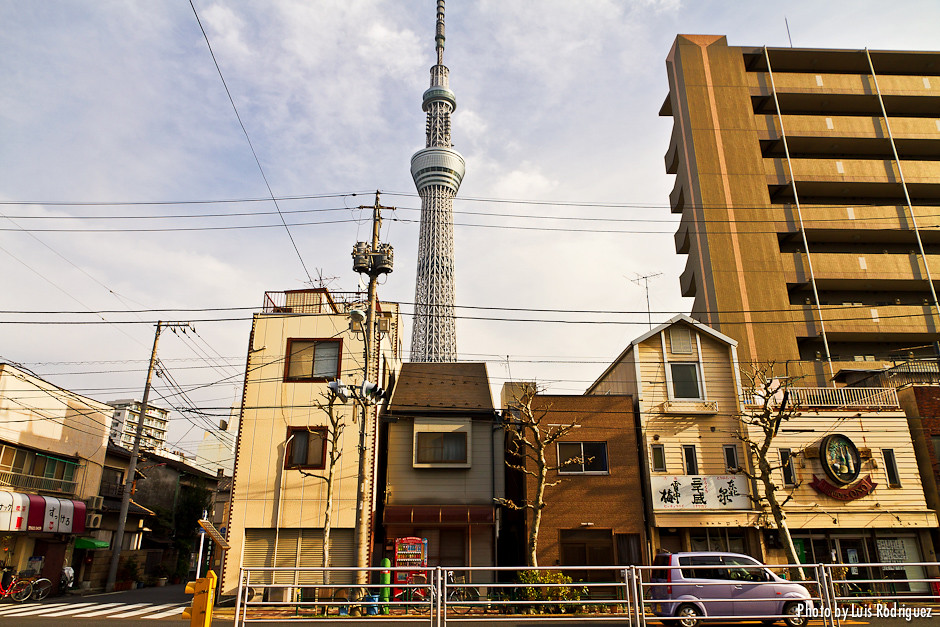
(0, 364, 113, 585)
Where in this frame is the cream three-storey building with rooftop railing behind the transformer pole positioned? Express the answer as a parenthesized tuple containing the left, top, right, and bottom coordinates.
(222, 288, 401, 598)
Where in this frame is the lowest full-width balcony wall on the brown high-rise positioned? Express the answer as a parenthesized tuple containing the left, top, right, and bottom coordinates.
(790, 304, 940, 343)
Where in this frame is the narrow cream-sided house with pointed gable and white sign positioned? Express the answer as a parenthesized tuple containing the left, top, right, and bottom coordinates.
(586, 315, 759, 555)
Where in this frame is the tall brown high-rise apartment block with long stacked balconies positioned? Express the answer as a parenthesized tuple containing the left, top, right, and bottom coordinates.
(660, 35, 940, 385)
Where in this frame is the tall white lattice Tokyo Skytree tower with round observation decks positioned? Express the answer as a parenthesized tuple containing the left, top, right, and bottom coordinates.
(411, 0, 466, 362)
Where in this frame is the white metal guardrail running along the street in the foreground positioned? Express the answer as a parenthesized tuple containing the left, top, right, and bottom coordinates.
(235, 562, 940, 627)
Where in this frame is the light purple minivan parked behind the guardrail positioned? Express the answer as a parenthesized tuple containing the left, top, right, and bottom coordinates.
(649, 551, 812, 627)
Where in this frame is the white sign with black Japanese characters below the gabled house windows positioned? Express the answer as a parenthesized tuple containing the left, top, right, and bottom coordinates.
(650, 475, 751, 510)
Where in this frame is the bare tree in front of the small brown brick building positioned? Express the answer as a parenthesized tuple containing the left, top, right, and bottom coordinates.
(494, 382, 584, 567)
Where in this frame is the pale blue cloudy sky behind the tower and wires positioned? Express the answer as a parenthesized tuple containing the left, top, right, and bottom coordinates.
(0, 0, 940, 462)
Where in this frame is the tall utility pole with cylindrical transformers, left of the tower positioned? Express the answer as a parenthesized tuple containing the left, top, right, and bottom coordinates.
(353, 191, 394, 584)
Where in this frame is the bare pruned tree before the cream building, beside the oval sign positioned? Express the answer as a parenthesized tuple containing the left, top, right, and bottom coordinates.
(735, 364, 805, 580)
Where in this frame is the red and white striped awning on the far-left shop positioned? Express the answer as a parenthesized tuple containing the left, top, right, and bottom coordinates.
(0, 491, 85, 533)
